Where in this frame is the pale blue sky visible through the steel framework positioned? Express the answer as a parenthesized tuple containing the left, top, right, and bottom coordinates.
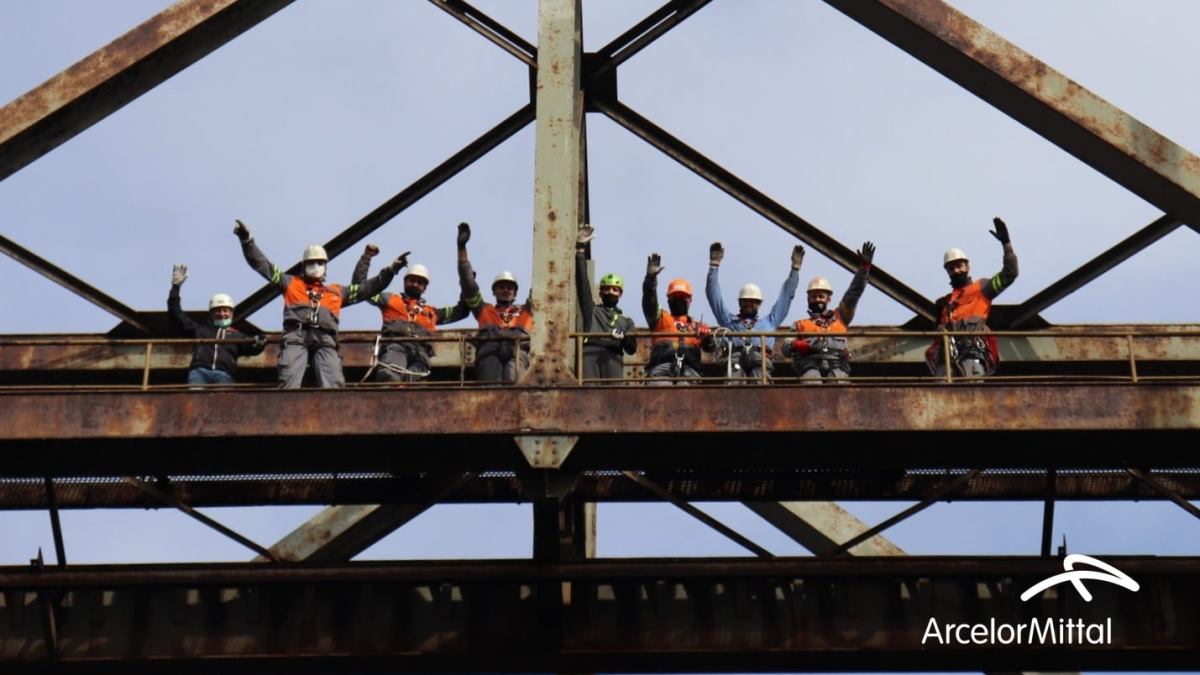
(0, 0, 1200, 667)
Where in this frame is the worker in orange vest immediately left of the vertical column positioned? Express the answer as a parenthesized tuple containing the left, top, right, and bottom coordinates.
(458, 222, 533, 382)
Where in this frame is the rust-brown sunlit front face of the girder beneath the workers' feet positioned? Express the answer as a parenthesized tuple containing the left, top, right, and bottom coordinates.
(0, 382, 1200, 441)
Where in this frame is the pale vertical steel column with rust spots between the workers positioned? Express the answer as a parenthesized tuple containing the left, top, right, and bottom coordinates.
(521, 0, 583, 386)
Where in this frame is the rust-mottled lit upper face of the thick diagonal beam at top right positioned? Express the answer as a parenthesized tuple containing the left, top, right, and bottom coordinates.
(877, 0, 1200, 196)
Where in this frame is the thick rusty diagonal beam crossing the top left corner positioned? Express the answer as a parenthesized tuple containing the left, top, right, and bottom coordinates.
(0, 0, 292, 180)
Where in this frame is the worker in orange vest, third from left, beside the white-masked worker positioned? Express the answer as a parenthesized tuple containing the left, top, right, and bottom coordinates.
(350, 239, 470, 382)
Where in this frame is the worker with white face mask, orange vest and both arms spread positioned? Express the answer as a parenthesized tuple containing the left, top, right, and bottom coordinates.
(233, 220, 408, 389)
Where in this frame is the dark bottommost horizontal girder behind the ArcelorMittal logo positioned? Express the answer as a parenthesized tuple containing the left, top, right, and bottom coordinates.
(0, 557, 1200, 674)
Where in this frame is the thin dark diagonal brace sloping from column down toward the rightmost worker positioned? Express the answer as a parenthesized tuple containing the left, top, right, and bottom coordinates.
(589, 100, 937, 322)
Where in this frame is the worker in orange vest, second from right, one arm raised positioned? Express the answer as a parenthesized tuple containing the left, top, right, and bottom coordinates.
(784, 241, 875, 383)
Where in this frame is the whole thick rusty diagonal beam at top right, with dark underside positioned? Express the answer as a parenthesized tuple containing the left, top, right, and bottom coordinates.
(826, 0, 1200, 232)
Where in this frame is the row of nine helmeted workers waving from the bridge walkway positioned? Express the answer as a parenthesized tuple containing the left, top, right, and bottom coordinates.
(167, 219, 1018, 389)
